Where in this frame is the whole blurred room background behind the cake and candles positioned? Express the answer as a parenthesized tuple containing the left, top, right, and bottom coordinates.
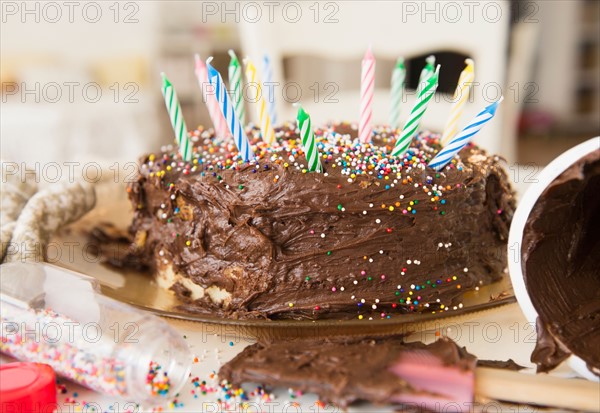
(0, 0, 600, 165)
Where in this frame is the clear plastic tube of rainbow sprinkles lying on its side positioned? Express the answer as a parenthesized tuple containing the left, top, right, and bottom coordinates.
(0, 263, 192, 403)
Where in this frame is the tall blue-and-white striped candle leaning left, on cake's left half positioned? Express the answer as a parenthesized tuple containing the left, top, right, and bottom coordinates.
(206, 57, 254, 162)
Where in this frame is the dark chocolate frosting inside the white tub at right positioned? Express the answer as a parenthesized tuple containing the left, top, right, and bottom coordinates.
(522, 150, 600, 374)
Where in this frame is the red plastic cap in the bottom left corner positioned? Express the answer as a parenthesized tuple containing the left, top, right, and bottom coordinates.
(0, 362, 57, 413)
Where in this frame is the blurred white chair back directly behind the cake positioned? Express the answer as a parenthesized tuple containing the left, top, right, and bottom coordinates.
(240, 1, 514, 155)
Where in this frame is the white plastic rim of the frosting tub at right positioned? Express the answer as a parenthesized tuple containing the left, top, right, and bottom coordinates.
(508, 136, 600, 381)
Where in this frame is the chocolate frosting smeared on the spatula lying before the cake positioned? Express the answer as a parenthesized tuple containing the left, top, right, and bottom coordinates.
(219, 337, 476, 407)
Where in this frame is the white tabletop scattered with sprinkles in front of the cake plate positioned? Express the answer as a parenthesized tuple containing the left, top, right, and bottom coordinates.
(0, 168, 574, 413)
